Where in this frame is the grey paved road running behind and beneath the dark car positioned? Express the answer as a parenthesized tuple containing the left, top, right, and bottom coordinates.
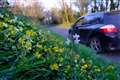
(49, 26, 120, 63)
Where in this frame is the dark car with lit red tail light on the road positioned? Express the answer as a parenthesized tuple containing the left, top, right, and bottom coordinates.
(69, 11, 120, 52)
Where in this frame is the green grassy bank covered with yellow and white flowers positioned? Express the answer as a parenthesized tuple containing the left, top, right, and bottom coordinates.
(0, 8, 119, 80)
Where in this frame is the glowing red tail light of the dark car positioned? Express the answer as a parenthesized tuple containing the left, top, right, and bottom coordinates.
(100, 25, 118, 33)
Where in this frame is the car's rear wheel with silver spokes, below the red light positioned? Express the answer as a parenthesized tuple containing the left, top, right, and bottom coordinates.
(89, 37, 102, 53)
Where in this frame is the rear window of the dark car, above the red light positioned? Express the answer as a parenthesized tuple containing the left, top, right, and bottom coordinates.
(103, 13, 120, 28)
